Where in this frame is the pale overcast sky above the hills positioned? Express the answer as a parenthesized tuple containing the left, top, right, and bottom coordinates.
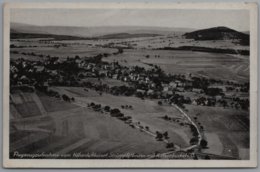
(11, 9, 249, 31)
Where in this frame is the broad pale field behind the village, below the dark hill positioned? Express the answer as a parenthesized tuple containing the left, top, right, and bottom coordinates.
(104, 50, 249, 82)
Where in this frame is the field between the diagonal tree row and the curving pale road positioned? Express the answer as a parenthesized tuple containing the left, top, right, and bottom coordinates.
(51, 87, 191, 147)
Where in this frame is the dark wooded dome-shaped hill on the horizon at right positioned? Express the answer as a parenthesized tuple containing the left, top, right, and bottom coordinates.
(183, 27, 249, 45)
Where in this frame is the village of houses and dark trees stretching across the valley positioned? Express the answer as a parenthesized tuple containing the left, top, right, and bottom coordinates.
(10, 49, 249, 111)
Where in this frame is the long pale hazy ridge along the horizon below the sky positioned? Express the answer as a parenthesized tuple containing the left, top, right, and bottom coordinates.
(11, 23, 192, 37)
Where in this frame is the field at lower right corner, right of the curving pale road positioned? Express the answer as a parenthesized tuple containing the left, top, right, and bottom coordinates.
(187, 105, 249, 159)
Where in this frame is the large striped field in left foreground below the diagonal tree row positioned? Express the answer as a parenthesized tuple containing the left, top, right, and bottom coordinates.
(11, 91, 169, 157)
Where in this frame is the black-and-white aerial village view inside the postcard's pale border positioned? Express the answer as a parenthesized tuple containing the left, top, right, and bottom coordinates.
(9, 9, 250, 160)
